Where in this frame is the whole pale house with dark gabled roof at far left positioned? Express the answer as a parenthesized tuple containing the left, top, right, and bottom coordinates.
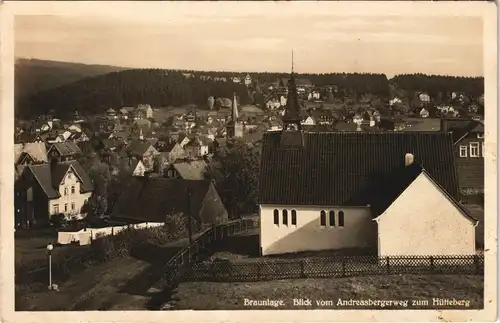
(15, 160, 93, 226)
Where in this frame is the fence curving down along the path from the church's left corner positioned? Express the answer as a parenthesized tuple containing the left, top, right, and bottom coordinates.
(165, 218, 259, 287)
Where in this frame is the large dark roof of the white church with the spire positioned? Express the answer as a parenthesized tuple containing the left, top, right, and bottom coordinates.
(259, 132, 459, 206)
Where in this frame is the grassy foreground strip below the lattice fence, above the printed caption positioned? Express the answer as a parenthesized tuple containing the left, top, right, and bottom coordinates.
(171, 275, 483, 310)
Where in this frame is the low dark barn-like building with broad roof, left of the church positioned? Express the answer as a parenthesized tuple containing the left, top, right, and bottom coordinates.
(113, 176, 228, 227)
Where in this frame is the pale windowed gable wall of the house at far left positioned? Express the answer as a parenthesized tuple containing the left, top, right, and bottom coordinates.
(49, 168, 92, 217)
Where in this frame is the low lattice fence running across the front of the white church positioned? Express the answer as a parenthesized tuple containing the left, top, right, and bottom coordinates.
(185, 255, 484, 282)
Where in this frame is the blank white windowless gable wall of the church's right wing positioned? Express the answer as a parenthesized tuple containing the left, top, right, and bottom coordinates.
(376, 173, 476, 256)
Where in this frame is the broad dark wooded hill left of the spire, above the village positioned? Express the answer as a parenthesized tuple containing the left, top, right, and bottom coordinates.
(18, 69, 250, 117)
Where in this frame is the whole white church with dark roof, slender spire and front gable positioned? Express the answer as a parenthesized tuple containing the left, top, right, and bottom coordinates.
(258, 72, 478, 256)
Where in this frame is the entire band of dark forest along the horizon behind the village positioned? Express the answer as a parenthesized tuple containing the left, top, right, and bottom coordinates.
(16, 65, 484, 118)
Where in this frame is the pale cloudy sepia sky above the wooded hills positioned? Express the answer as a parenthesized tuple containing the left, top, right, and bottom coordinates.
(14, 11, 483, 77)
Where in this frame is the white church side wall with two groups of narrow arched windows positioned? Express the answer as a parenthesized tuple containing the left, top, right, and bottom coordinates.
(260, 205, 377, 255)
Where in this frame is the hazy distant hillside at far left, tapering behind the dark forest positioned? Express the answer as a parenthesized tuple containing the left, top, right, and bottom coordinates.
(15, 58, 125, 98)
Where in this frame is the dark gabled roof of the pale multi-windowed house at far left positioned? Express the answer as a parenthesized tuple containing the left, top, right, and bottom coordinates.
(25, 160, 93, 199)
